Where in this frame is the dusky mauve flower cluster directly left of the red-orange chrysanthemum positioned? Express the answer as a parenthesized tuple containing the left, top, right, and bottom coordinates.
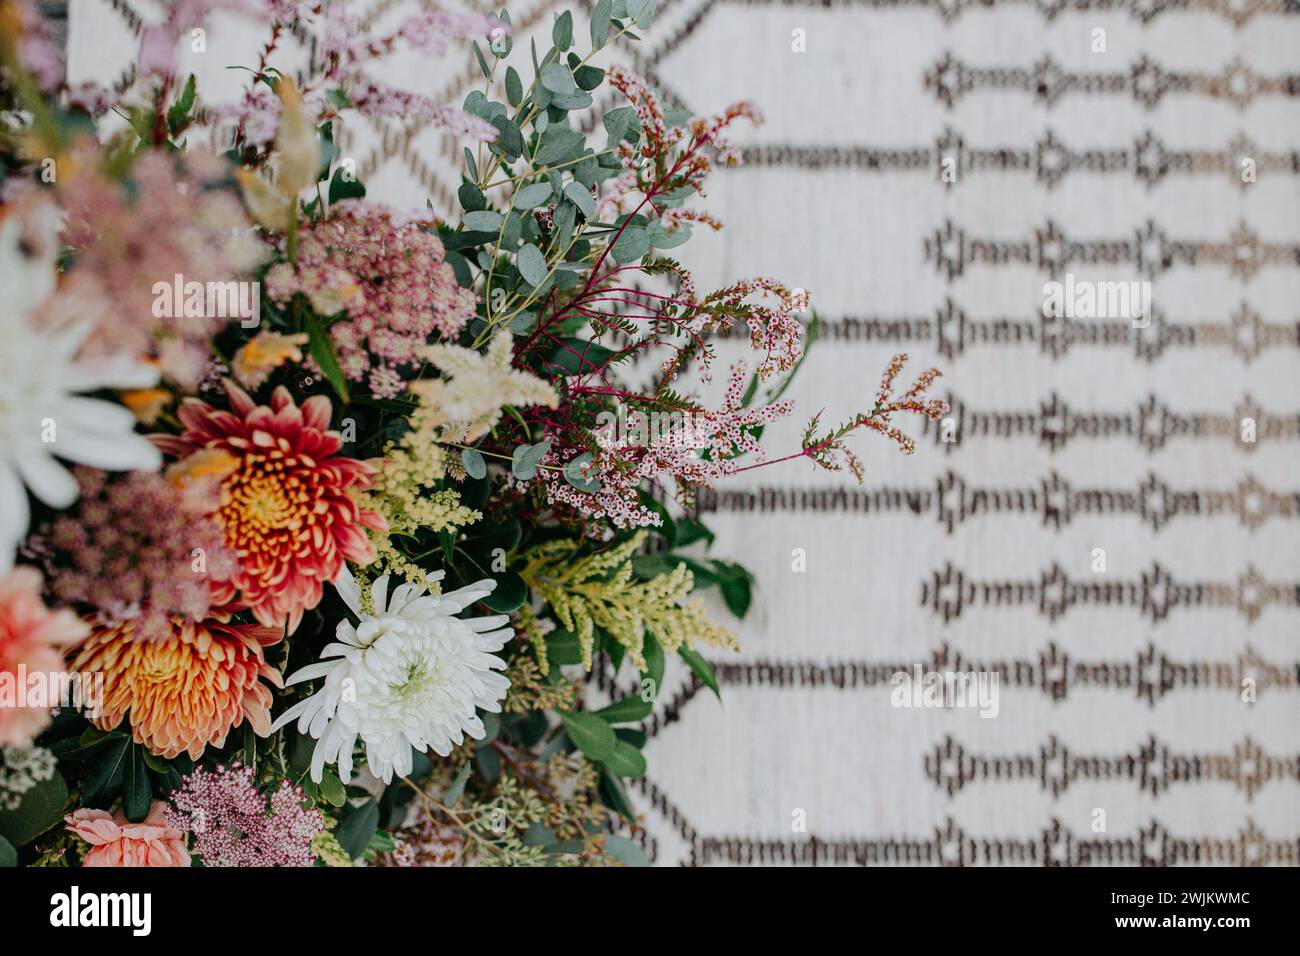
(29, 468, 239, 640)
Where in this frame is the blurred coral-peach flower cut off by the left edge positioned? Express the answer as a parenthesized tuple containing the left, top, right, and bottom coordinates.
(0, 567, 88, 747)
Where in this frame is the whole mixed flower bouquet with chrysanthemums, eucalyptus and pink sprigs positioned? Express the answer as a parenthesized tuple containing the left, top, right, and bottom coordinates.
(0, 0, 944, 866)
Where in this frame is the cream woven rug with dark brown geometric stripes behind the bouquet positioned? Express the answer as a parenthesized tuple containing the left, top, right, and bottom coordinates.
(69, 0, 1300, 865)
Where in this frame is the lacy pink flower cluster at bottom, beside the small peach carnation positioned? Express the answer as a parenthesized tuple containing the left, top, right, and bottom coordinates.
(164, 763, 325, 866)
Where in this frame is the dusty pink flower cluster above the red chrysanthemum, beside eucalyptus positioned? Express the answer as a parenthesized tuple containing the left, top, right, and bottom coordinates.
(265, 202, 476, 398)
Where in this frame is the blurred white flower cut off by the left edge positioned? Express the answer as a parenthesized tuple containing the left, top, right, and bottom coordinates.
(0, 195, 163, 572)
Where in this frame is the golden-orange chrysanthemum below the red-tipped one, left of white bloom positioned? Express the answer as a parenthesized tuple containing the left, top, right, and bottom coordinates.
(70, 619, 283, 760)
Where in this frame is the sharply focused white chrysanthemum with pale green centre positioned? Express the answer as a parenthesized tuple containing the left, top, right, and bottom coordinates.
(272, 566, 515, 783)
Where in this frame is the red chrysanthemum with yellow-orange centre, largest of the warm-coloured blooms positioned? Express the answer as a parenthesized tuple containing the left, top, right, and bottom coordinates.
(155, 380, 385, 633)
